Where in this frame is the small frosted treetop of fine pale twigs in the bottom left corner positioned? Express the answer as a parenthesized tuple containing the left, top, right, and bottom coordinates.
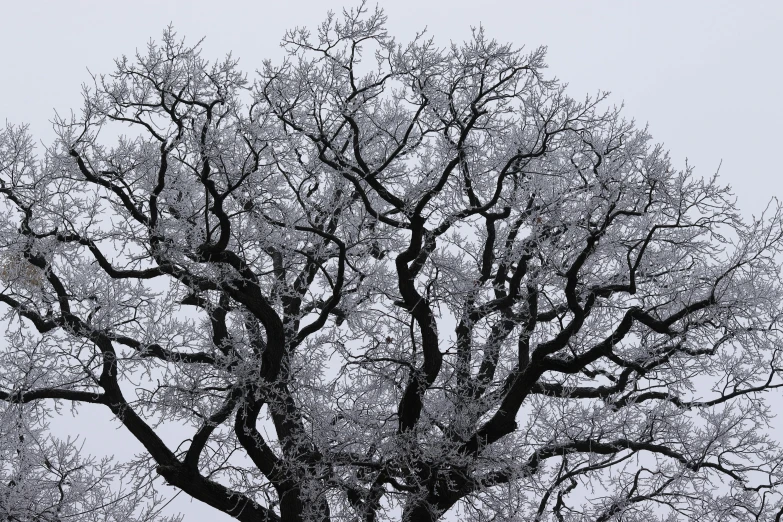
(0, 404, 181, 522)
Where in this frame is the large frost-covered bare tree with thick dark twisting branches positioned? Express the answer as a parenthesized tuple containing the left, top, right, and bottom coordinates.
(0, 5, 783, 522)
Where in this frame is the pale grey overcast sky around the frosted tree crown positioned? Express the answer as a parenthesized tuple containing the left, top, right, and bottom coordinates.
(0, 0, 783, 522)
